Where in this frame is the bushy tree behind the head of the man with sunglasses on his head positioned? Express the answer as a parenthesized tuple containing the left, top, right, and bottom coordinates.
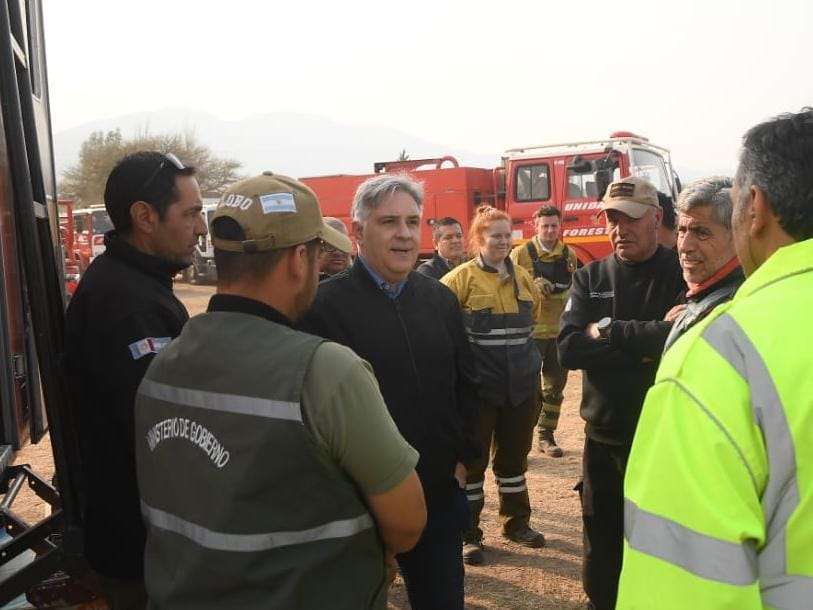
(60, 129, 240, 207)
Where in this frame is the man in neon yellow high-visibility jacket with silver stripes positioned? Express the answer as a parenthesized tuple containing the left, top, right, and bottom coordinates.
(616, 108, 813, 610)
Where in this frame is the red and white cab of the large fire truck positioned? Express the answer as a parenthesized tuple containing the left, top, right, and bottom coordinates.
(501, 131, 680, 263)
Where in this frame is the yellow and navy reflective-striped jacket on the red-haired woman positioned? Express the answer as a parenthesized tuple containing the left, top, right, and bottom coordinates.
(441, 256, 542, 405)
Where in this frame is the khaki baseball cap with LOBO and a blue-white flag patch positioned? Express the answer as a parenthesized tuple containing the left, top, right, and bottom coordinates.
(209, 172, 352, 253)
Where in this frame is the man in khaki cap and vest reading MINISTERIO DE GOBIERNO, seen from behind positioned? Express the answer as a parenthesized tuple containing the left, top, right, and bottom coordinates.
(135, 172, 426, 610)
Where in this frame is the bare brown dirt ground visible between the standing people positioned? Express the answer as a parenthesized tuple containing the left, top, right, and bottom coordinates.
(14, 283, 586, 610)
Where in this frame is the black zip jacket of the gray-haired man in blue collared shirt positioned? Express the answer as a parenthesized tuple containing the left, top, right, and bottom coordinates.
(302, 261, 478, 502)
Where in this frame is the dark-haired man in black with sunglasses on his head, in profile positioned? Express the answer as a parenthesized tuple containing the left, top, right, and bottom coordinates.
(66, 152, 206, 610)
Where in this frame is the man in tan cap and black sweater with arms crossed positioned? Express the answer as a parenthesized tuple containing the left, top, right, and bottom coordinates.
(558, 177, 686, 610)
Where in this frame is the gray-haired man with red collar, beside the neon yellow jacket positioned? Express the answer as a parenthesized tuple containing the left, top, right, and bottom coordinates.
(664, 176, 745, 350)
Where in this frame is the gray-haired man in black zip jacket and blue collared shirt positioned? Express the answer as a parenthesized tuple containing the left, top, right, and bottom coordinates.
(303, 175, 478, 610)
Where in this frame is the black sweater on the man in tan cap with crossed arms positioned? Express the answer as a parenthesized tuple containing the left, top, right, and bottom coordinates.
(557, 246, 686, 444)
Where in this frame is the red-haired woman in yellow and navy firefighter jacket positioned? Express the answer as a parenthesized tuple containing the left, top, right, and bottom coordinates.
(441, 206, 545, 564)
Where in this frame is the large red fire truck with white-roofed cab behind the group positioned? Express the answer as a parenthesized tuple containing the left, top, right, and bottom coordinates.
(302, 131, 680, 263)
